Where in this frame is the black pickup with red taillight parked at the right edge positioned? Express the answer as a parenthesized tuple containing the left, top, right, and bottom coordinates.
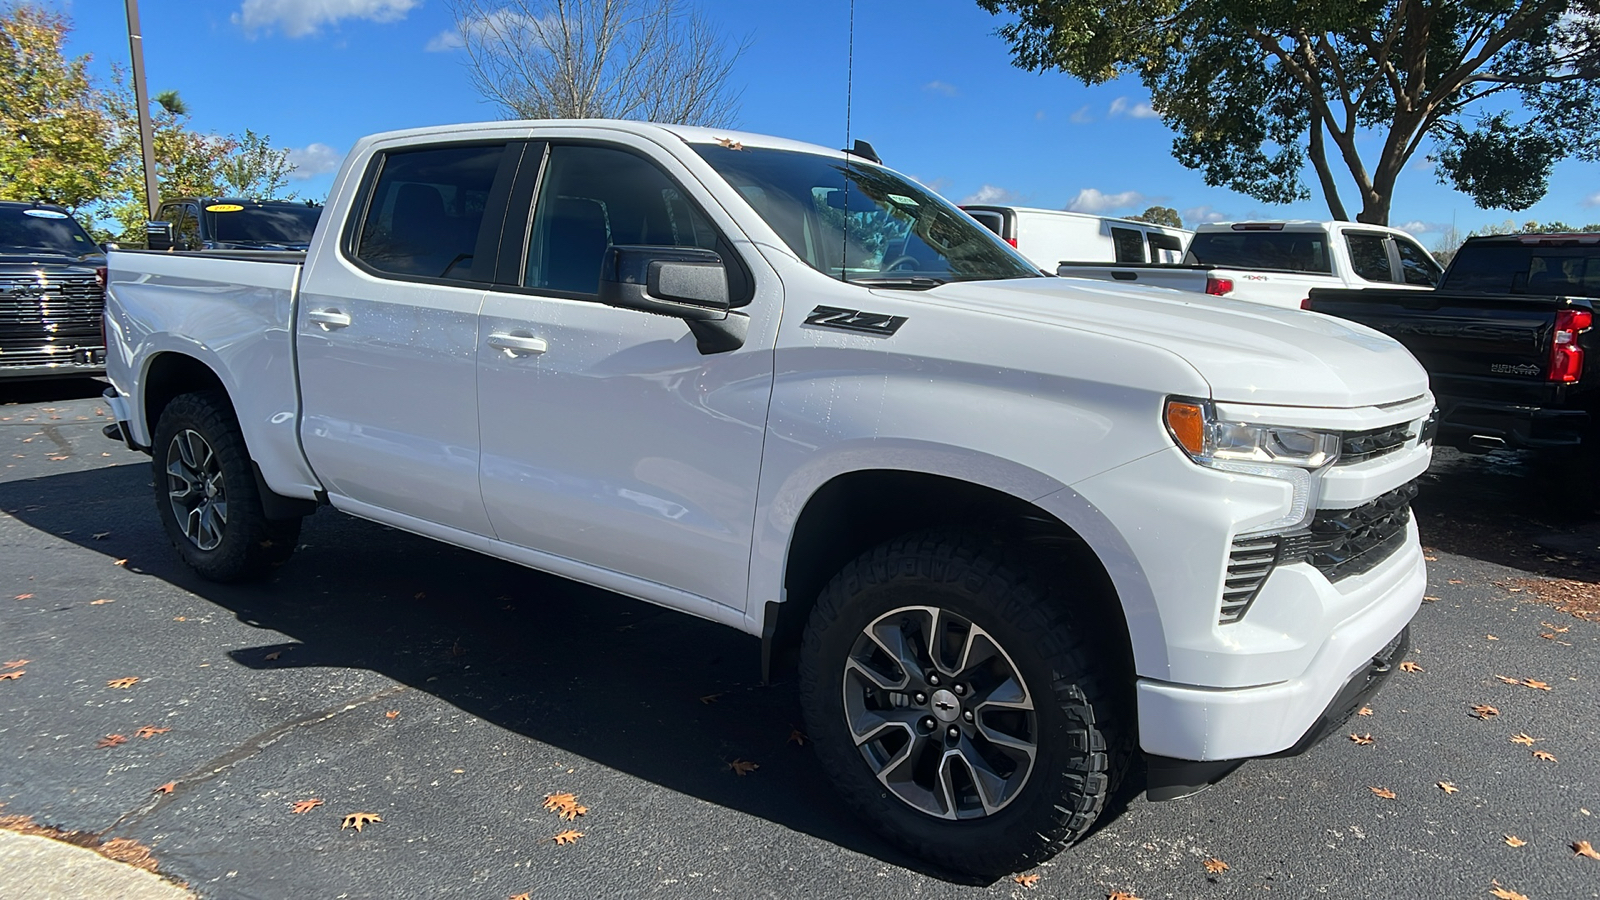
(1302, 234, 1600, 456)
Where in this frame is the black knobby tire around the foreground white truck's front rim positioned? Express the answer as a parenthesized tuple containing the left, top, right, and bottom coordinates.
(800, 532, 1134, 878)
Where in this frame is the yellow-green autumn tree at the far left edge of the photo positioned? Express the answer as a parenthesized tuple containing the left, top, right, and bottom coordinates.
(0, 6, 114, 211)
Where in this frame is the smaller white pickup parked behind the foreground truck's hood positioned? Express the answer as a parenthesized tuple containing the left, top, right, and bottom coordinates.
(1056, 221, 1443, 309)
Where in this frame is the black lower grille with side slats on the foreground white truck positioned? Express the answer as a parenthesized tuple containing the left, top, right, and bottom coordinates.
(1218, 482, 1416, 625)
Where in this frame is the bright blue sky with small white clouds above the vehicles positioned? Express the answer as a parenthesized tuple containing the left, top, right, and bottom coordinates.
(45, 0, 1600, 245)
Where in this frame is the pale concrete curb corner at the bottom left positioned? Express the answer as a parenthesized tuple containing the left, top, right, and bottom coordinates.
(0, 830, 195, 900)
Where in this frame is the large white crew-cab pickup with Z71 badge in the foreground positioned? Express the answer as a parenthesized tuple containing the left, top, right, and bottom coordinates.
(106, 120, 1434, 874)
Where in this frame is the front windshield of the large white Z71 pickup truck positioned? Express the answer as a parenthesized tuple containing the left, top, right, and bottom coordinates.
(694, 144, 1040, 288)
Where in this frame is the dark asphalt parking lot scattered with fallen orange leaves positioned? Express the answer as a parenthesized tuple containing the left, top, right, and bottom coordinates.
(0, 381, 1600, 900)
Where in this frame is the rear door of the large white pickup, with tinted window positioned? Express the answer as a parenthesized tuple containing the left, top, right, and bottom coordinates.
(296, 141, 522, 535)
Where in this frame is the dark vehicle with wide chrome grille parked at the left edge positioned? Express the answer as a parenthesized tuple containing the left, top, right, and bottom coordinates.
(0, 202, 106, 378)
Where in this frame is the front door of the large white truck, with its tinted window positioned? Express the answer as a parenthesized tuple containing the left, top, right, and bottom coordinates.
(478, 143, 779, 610)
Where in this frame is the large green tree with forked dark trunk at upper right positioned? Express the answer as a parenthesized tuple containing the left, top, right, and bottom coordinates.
(978, 0, 1600, 224)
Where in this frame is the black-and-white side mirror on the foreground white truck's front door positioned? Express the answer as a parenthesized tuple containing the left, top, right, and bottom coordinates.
(600, 245, 750, 354)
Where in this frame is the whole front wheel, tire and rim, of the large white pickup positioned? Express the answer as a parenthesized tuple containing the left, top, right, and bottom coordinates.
(800, 532, 1133, 876)
